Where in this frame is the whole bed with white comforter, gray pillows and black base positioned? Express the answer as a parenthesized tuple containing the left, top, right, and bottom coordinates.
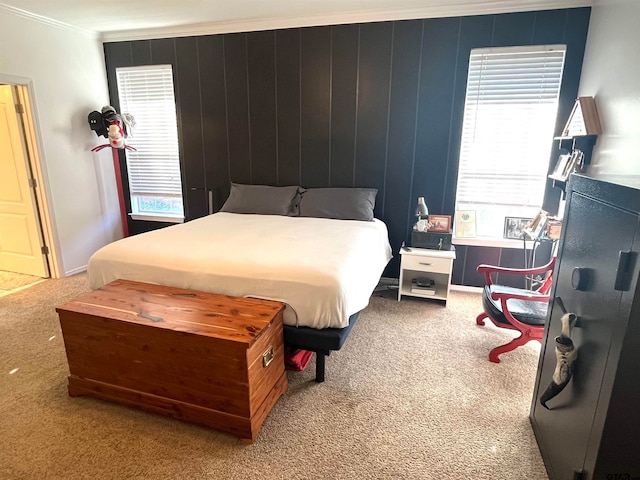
(88, 184, 391, 382)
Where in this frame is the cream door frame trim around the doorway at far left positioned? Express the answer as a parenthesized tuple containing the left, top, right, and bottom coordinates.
(0, 72, 61, 278)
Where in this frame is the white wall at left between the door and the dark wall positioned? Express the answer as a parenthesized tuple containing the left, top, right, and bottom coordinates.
(0, 9, 122, 276)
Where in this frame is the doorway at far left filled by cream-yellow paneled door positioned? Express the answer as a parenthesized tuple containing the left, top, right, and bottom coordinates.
(0, 80, 51, 281)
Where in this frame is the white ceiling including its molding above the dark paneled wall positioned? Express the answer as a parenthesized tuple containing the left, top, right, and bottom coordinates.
(0, 0, 596, 41)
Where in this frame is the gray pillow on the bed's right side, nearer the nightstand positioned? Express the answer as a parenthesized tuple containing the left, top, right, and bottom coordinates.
(300, 188, 378, 221)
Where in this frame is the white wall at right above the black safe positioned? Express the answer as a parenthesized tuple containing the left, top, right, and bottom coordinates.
(579, 0, 640, 175)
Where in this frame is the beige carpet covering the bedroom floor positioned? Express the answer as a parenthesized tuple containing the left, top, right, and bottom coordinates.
(0, 275, 547, 480)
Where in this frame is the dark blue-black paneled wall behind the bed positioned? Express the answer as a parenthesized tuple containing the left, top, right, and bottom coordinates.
(104, 8, 590, 276)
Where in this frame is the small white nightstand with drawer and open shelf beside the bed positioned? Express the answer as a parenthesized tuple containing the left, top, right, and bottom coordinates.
(398, 247, 456, 304)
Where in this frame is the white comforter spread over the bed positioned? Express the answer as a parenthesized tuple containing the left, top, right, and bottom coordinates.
(88, 212, 392, 329)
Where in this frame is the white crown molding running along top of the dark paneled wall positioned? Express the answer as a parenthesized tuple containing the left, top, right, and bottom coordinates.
(101, 0, 594, 43)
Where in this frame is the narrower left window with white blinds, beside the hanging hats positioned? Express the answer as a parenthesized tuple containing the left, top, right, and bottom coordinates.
(116, 65, 184, 222)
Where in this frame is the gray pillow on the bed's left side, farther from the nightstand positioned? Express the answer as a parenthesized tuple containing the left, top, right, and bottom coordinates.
(220, 183, 300, 216)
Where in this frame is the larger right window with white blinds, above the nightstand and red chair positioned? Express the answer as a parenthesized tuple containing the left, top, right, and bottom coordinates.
(456, 45, 566, 238)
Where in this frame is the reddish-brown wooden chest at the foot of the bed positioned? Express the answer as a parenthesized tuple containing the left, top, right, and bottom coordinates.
(56, 280, 287, 442)
